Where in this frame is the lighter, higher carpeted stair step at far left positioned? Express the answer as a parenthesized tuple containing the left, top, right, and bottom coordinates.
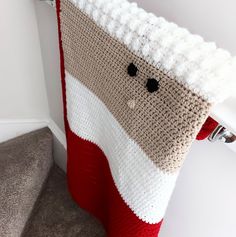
(0, 128, 53, 237)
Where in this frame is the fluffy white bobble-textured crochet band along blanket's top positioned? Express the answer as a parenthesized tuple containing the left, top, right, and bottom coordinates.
(67, 0, 236, 104)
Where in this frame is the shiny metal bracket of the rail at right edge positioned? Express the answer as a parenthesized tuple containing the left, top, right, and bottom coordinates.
(208, 125, 236, 143)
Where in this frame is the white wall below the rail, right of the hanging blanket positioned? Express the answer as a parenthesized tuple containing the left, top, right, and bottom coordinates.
(160, 141, 236, 237)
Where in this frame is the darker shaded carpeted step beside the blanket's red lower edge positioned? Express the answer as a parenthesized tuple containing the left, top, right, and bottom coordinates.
(23, 167, 105, 237)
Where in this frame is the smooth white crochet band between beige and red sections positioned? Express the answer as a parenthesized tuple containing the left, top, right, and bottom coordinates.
(66, 72, 178, 224)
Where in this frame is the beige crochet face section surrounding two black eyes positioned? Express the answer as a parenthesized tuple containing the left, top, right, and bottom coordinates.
(61, 0, 210, 173)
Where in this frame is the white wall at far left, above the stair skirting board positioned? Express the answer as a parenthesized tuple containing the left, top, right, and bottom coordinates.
(0, 0, 49, 118)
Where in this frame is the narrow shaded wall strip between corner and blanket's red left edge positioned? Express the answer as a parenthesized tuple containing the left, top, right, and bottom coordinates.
(35, 1, 64, 131)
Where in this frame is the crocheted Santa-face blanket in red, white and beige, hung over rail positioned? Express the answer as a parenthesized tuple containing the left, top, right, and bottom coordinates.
(57, 0, 236, 237)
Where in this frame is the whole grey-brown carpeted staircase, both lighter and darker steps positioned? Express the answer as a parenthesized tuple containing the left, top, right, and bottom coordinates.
(0, 128, 105, 237)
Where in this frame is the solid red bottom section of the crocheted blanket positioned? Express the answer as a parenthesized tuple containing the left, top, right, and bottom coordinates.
(67, 130, 161, 237)
